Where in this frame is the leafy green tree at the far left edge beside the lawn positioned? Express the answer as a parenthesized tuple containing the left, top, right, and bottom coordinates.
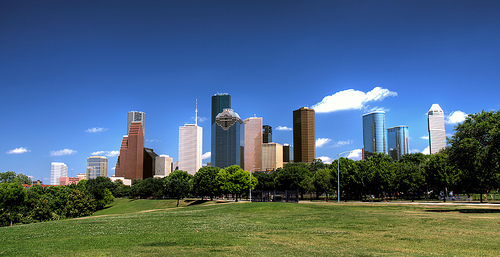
(0, 182, 27, 226)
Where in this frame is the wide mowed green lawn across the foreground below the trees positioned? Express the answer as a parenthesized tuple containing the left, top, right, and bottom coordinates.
(0, 199, 500, 256)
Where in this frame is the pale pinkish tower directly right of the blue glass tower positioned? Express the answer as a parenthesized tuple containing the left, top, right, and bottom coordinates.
(243, 117, 262, 172)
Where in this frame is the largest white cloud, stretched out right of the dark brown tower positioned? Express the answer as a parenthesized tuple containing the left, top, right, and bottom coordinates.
(312, 87, 398, 113)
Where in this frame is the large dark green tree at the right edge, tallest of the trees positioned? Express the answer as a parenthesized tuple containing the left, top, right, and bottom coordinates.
(448, 111, 500, 202)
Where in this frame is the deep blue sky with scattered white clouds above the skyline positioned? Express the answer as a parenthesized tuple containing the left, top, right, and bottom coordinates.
(0, 0, 500, 183)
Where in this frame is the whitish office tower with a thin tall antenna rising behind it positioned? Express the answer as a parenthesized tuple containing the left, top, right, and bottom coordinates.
(179, 124, 203, 175)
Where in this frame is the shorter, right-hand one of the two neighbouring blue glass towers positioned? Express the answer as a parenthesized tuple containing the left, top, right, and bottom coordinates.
(387, 126, 410, 161)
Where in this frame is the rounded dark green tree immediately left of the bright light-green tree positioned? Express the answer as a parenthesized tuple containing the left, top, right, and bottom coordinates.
(193, 167, 220, 200)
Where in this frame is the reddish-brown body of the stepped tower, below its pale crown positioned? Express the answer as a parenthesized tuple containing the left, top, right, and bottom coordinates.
(115, 122, 144, 180)
